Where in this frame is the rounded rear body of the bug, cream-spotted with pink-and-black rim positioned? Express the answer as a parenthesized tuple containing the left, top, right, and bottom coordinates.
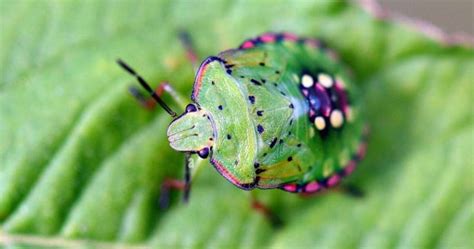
(215, 34, 365, 192)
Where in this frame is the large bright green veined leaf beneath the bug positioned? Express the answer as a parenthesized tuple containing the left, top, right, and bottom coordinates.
(0, 0, 474, 248)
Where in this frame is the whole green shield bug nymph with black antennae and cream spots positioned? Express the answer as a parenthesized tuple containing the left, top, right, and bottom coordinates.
(118, 33, 366, 201)
